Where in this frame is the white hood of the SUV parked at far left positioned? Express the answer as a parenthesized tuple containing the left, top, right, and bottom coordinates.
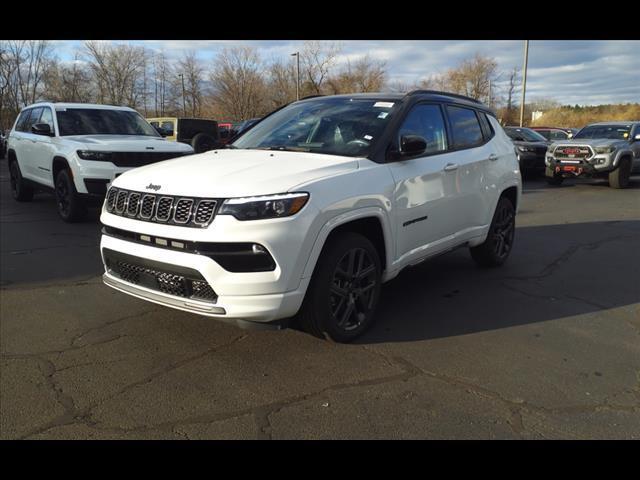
(64, 135, 193, 152)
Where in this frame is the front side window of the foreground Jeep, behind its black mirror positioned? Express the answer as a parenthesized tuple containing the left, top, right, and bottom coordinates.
(398, 104, 447, 154)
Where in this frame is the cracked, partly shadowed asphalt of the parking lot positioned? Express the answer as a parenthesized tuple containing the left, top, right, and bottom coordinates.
(0, 162, 640, 439)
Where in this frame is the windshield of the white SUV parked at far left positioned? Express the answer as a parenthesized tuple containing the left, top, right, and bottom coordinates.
(56, 108, 160, 137)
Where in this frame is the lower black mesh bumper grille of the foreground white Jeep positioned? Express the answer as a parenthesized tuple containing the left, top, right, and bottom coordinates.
(102, 248, 218, 303)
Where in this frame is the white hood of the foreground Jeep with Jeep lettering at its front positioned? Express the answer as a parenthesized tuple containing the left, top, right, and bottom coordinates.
(114, 150, 358, 198)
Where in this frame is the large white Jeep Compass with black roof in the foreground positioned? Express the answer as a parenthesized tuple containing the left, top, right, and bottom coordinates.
(101, 91, 521, 342)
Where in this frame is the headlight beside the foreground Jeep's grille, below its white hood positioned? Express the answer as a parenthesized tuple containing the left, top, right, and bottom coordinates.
(218, 192, 309, 220)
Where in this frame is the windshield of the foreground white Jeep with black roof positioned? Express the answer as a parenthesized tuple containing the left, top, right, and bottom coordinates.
(233, 97, 394, 157)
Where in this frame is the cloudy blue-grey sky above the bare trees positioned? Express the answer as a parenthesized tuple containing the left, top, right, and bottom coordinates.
(54, 40, 640, 105)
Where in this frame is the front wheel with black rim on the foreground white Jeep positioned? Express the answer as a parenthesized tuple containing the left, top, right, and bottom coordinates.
(297, 232, 382, 343)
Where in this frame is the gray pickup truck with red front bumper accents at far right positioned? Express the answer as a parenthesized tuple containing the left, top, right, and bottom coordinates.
(545, 121, 640, 188)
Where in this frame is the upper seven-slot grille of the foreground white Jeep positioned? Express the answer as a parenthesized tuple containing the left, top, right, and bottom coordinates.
(105, 187, 218, 228)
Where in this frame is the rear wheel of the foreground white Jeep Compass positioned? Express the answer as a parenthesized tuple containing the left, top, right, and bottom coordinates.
(470, 197, 516, 267)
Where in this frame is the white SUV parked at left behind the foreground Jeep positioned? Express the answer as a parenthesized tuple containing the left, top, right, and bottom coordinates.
(7, 103, 193, 222)
